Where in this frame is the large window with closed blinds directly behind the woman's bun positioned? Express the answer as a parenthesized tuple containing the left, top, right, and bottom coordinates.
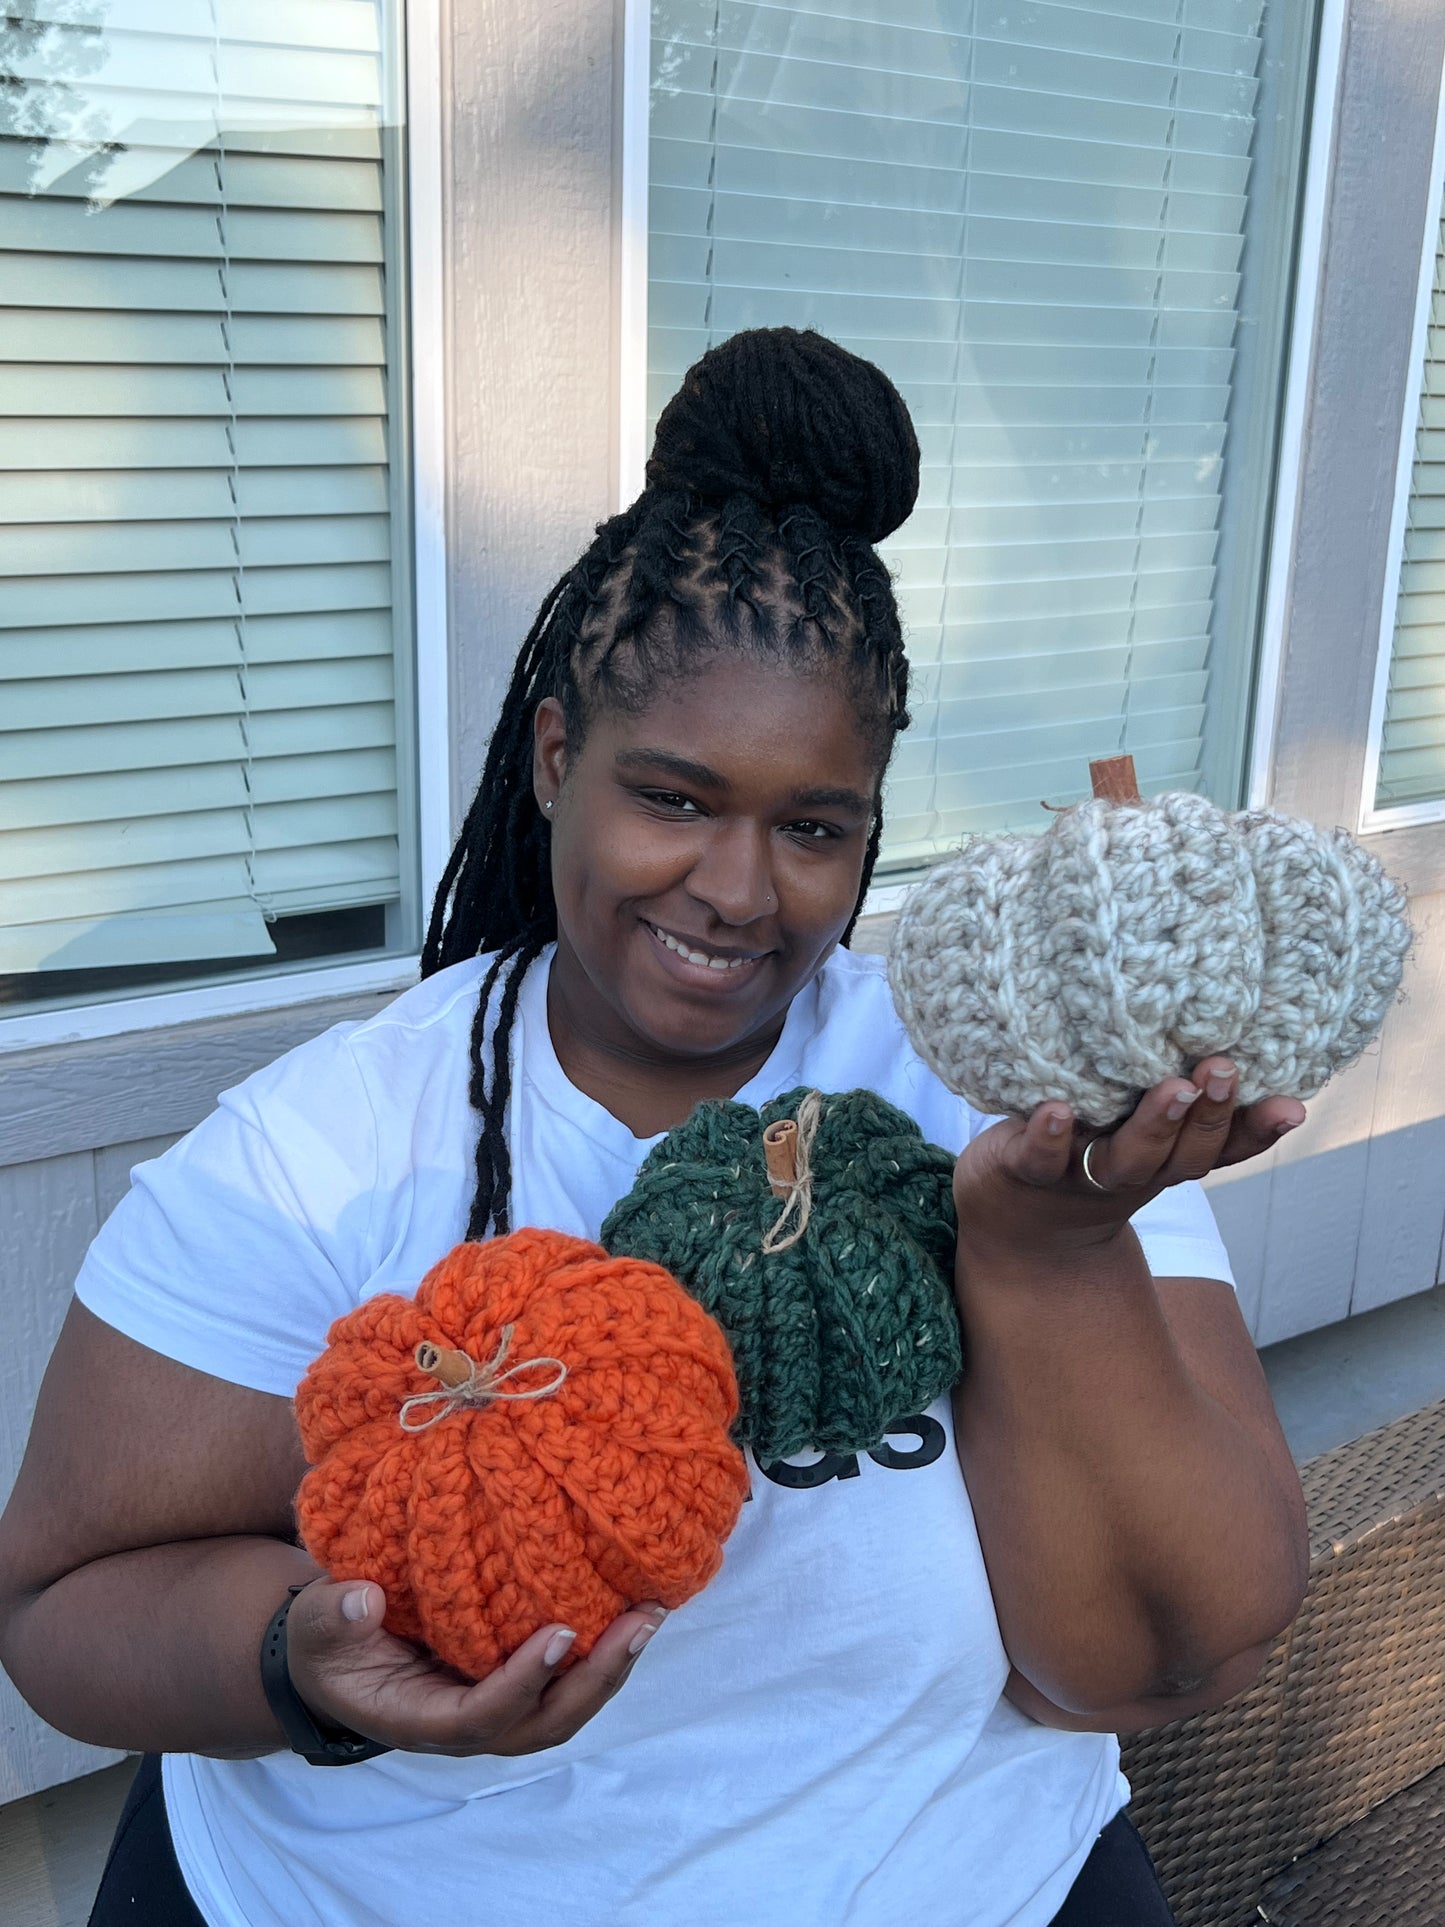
(647, 0, 1314, 871)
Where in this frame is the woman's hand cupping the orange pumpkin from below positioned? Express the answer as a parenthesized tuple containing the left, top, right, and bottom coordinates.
(287, 1578, 667, 1755)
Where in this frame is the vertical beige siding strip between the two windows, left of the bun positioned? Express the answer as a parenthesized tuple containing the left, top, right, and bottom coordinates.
(447, 0, 620, 819)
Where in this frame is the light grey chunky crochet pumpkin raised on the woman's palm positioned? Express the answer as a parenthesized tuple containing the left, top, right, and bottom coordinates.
(888, 794, 1410, 1125)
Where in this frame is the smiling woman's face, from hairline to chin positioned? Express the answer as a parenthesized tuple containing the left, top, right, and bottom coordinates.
(534, 655, 880, 1066)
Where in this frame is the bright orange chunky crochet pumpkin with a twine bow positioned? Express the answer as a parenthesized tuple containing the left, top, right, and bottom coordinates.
(297, 1229, 748, 1678)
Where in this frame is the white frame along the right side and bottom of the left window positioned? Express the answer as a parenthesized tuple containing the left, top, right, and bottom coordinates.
(0, 0, 452, 1054)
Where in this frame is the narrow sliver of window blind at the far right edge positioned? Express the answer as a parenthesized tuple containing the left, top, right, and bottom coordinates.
(1376, 208, 1445, 809)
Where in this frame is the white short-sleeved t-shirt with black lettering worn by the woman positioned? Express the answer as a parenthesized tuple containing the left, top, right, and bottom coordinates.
(77, 952, 1229, 1927)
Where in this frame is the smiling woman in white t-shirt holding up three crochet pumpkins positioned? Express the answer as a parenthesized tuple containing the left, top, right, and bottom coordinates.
(0, 330, 1304, 1927)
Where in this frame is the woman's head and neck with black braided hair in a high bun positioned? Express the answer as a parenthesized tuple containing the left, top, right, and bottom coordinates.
(422, 328, 919, 1237)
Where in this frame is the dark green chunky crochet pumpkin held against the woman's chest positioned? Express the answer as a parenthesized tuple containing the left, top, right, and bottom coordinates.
(601, 1091, 963, 1459)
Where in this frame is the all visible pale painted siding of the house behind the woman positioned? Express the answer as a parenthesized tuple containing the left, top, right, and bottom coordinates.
(0, 0, 1445, 1802)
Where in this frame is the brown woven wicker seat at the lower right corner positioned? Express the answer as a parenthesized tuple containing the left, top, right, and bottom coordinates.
(1123, 1403, 1445, 1927)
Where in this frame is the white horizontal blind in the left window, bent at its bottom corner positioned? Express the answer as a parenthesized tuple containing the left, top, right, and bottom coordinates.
(0, 0, 399, 971)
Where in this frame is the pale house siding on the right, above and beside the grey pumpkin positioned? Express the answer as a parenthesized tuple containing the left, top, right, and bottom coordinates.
(1210, 0, 1445, 1345)
